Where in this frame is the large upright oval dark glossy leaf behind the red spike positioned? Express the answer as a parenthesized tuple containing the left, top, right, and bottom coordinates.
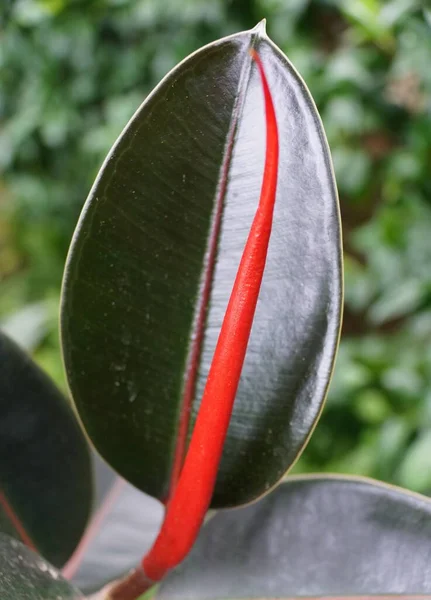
(62, 21, 342, 506)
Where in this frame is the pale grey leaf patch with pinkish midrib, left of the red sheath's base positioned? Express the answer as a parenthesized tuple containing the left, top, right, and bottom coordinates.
(63, 459, 163, 593)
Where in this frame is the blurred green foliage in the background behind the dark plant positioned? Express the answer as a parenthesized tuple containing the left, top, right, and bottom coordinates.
(0, 0, 431, 493)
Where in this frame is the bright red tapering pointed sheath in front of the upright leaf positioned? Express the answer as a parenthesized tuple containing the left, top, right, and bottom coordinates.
(142, 50, 278, 581)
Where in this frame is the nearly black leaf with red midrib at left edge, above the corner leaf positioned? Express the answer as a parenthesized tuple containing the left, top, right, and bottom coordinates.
(0, 334, 92, 566)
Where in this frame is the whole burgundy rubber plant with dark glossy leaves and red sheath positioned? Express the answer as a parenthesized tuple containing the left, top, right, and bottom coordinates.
(0, 23, 431, 600)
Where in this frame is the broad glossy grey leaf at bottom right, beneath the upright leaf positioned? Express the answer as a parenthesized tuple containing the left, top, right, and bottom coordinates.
(157, 477, 431, 600)
